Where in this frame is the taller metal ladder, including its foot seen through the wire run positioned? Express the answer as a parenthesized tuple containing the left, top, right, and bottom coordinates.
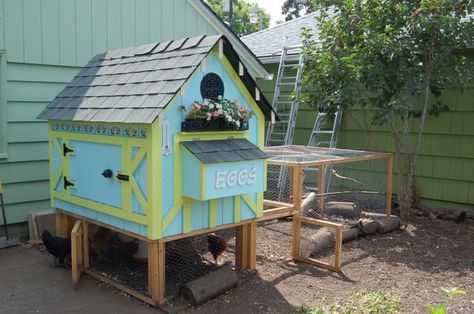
(265, 38, 304, 201)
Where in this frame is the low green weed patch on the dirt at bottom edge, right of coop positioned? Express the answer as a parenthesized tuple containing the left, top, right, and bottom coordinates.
(298, 291, 401, 314)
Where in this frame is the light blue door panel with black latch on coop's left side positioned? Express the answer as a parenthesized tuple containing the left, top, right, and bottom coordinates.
(69, 141, 122, 208)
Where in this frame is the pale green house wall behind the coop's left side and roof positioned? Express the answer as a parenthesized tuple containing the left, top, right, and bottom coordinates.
(0, 0, 217, 223)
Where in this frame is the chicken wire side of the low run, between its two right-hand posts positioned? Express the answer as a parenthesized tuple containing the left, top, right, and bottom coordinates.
(302, 159, 387, 224)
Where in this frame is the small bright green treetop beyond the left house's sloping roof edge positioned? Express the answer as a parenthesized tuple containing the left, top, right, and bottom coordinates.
(206, 0, 270, 37)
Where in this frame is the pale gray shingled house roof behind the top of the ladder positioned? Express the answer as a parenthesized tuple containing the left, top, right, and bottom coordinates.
(241, 12, 317, 62)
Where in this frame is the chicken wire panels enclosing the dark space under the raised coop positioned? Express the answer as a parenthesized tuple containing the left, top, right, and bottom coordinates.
(88, 224, 235, 297)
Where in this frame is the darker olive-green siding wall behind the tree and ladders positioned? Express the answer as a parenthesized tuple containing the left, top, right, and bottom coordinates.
(259, 64, 474, 208)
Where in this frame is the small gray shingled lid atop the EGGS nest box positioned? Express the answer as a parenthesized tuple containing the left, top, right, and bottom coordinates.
(181, 139, 269, 164)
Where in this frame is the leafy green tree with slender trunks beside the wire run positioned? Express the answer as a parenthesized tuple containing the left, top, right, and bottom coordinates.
(302, 0, 474, 218)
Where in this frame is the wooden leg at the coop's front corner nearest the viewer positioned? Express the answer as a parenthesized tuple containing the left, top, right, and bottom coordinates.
(148, 241, 165, 305)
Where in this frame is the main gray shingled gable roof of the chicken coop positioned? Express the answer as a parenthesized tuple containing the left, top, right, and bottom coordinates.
(38, 35, 273, 123)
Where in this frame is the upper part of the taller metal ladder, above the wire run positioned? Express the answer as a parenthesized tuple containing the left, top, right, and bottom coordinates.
(266, 39, 304, 146)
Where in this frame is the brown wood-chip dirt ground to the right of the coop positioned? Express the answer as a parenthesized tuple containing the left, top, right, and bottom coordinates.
(175, 218, 474, 313)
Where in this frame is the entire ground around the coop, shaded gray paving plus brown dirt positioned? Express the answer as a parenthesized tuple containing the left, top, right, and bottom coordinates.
(9, 218, 474, 314)
